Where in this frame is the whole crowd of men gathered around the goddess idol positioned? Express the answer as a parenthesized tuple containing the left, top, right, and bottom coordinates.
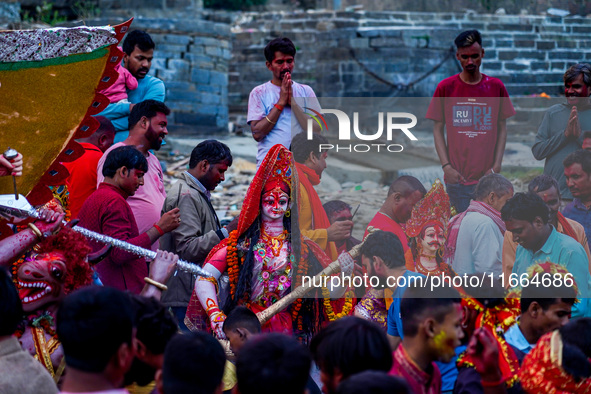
(0, 26, 591, 394)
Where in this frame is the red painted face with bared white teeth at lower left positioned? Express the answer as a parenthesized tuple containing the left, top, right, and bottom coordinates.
(17, 252, 67, 312)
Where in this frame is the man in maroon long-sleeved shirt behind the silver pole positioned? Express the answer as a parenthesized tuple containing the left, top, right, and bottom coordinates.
(78, 146, 180, 294)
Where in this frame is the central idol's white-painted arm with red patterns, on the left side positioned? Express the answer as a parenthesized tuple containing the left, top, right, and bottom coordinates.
(195, 248, 227, 339)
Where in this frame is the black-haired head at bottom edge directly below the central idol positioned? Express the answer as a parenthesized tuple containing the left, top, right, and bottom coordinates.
(236, 333, 312, 394)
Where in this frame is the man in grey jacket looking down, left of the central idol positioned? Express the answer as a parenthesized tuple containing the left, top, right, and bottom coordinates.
(160, 140, 235, 331)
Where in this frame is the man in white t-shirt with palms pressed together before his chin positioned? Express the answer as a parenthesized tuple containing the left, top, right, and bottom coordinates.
(246, 37, 320, 166)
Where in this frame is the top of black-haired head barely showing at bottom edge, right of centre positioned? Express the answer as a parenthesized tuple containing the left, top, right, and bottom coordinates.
(336, 371, 411, 394)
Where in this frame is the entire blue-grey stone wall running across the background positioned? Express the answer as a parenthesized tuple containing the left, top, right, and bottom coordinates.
(85, 11, 591, 132)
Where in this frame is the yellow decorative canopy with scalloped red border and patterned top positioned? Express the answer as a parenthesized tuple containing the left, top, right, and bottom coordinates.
(0, 19, 132, 205)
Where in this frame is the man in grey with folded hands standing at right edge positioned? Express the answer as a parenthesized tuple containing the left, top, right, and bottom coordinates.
(531, 63, 591, 200)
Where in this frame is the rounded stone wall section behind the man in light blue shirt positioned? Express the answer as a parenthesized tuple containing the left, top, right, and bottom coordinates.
(91, 14, 232, 133)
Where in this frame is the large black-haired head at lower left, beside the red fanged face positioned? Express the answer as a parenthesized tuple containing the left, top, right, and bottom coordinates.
(56, 286, 133, 373)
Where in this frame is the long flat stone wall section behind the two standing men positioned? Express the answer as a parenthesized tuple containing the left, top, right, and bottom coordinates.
(229, 11, 591, 133)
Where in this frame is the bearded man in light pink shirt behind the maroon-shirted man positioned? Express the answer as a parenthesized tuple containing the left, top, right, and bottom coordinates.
(97, 100, 175, 250)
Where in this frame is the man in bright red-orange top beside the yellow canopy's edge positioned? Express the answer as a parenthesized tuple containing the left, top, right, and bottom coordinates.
(62, 116, 115, 219)
